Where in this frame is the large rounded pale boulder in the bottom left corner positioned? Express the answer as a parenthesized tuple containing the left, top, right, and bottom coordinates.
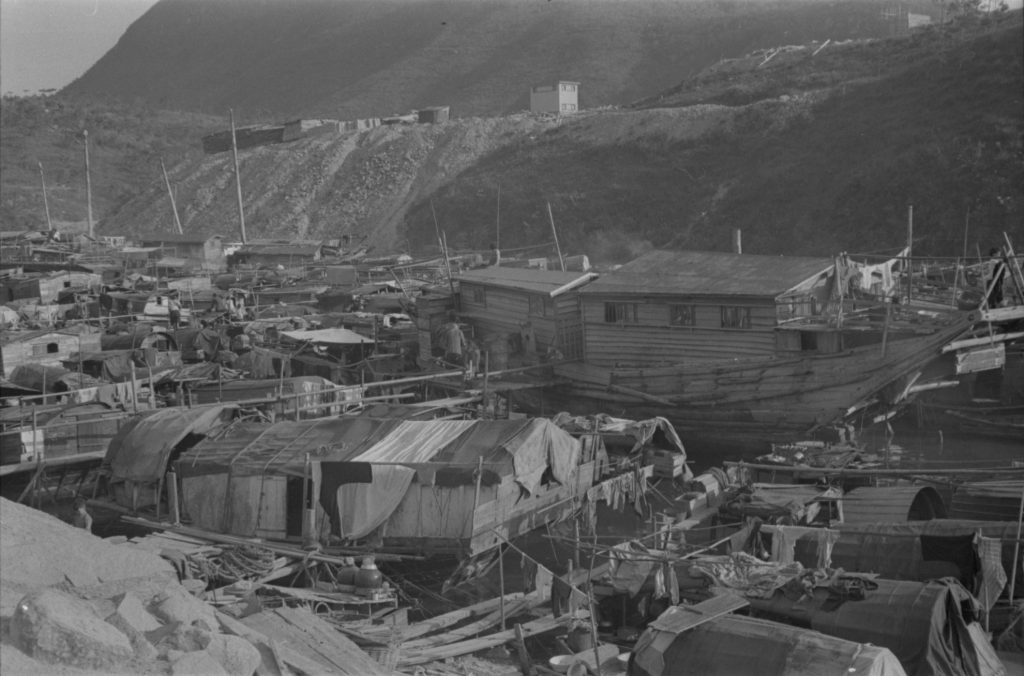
(10, 589, 134, 669)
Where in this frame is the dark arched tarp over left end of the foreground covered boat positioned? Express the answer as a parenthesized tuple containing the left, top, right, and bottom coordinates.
(103, 405, 236, 481)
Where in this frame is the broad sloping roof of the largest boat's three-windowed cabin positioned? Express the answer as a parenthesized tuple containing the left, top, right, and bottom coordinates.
(581, 250, 833, 298)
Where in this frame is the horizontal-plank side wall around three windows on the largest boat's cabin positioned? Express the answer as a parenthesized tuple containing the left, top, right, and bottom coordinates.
(582, 296, 776, 367)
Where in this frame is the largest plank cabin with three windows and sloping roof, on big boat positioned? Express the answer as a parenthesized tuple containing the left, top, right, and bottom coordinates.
(580, 251, 833, 368)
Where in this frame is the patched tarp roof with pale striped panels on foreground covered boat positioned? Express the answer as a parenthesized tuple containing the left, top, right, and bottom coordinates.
(177, 417, 580, 539)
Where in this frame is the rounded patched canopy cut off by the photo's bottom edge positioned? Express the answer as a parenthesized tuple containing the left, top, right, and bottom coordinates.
(629, 615, 906, 676)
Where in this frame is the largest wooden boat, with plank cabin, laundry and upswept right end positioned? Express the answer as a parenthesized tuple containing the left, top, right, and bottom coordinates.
(461, 251, 1007, 450)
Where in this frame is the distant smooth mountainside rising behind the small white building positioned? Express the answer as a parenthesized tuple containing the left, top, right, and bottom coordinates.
(63, 0, 917, 120)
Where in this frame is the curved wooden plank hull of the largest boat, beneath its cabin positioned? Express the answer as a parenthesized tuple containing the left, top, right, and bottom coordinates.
(517, 315, 970, 452)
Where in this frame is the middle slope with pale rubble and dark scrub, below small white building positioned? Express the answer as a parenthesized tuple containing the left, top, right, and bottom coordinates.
(81, 12, 1024, 260)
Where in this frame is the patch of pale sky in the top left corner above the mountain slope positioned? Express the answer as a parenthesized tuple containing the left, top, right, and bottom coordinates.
(0, 0, 157, 95)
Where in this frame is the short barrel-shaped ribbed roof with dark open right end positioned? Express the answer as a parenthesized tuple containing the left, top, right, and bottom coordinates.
(843, 485, 946, 523)
